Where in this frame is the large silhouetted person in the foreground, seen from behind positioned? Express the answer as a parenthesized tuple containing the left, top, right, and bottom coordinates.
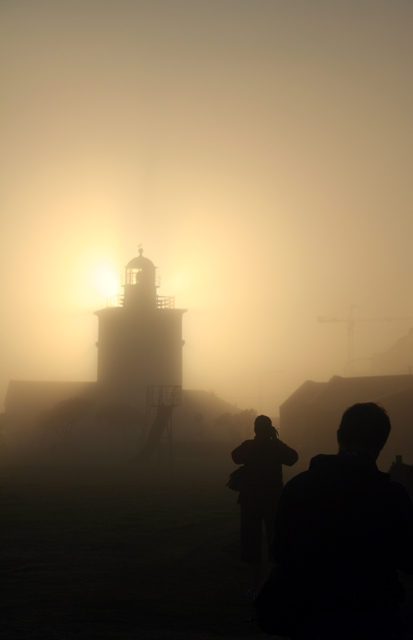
(273, 403, 413, 640)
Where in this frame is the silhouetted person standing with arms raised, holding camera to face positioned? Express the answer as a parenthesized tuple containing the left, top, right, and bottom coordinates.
(231, 416, 298, 596)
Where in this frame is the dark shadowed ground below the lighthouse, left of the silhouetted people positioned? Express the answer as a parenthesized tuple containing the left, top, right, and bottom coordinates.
(0, 446, 413, 640)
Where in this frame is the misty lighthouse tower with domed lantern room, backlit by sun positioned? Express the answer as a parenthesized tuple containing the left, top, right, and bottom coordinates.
(95, 249, 186, 408)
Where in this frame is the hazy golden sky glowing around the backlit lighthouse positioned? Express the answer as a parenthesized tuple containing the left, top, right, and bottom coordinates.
(0, 0, 413, 415)
